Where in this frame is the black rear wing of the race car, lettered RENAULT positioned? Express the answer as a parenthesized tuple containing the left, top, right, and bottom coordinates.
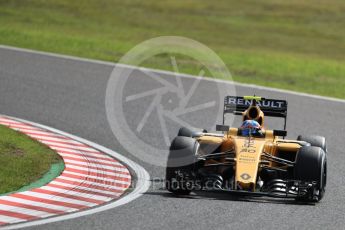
(223, 96, 288, 129)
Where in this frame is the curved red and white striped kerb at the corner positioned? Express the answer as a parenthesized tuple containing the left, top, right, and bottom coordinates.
(0, 115, 131, 226)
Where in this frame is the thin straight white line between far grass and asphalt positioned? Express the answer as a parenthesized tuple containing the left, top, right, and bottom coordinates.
(0, 45, 345, 103)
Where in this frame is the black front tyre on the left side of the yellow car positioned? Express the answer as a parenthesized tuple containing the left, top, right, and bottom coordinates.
(165, 136, 199, 195)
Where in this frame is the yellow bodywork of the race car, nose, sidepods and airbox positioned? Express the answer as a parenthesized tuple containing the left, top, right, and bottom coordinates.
(197, 107, 301, 191)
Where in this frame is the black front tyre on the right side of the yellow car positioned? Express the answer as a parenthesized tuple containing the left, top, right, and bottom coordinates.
(294, 146, 327, 202)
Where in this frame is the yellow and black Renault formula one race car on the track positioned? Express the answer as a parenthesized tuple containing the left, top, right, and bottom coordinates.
(166, 96, 327, 202)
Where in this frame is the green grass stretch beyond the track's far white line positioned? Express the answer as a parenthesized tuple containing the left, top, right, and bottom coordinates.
(0, 0, 345, 98)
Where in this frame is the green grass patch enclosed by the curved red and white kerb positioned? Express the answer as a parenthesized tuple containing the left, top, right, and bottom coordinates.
(0, 125, 62, 194)
